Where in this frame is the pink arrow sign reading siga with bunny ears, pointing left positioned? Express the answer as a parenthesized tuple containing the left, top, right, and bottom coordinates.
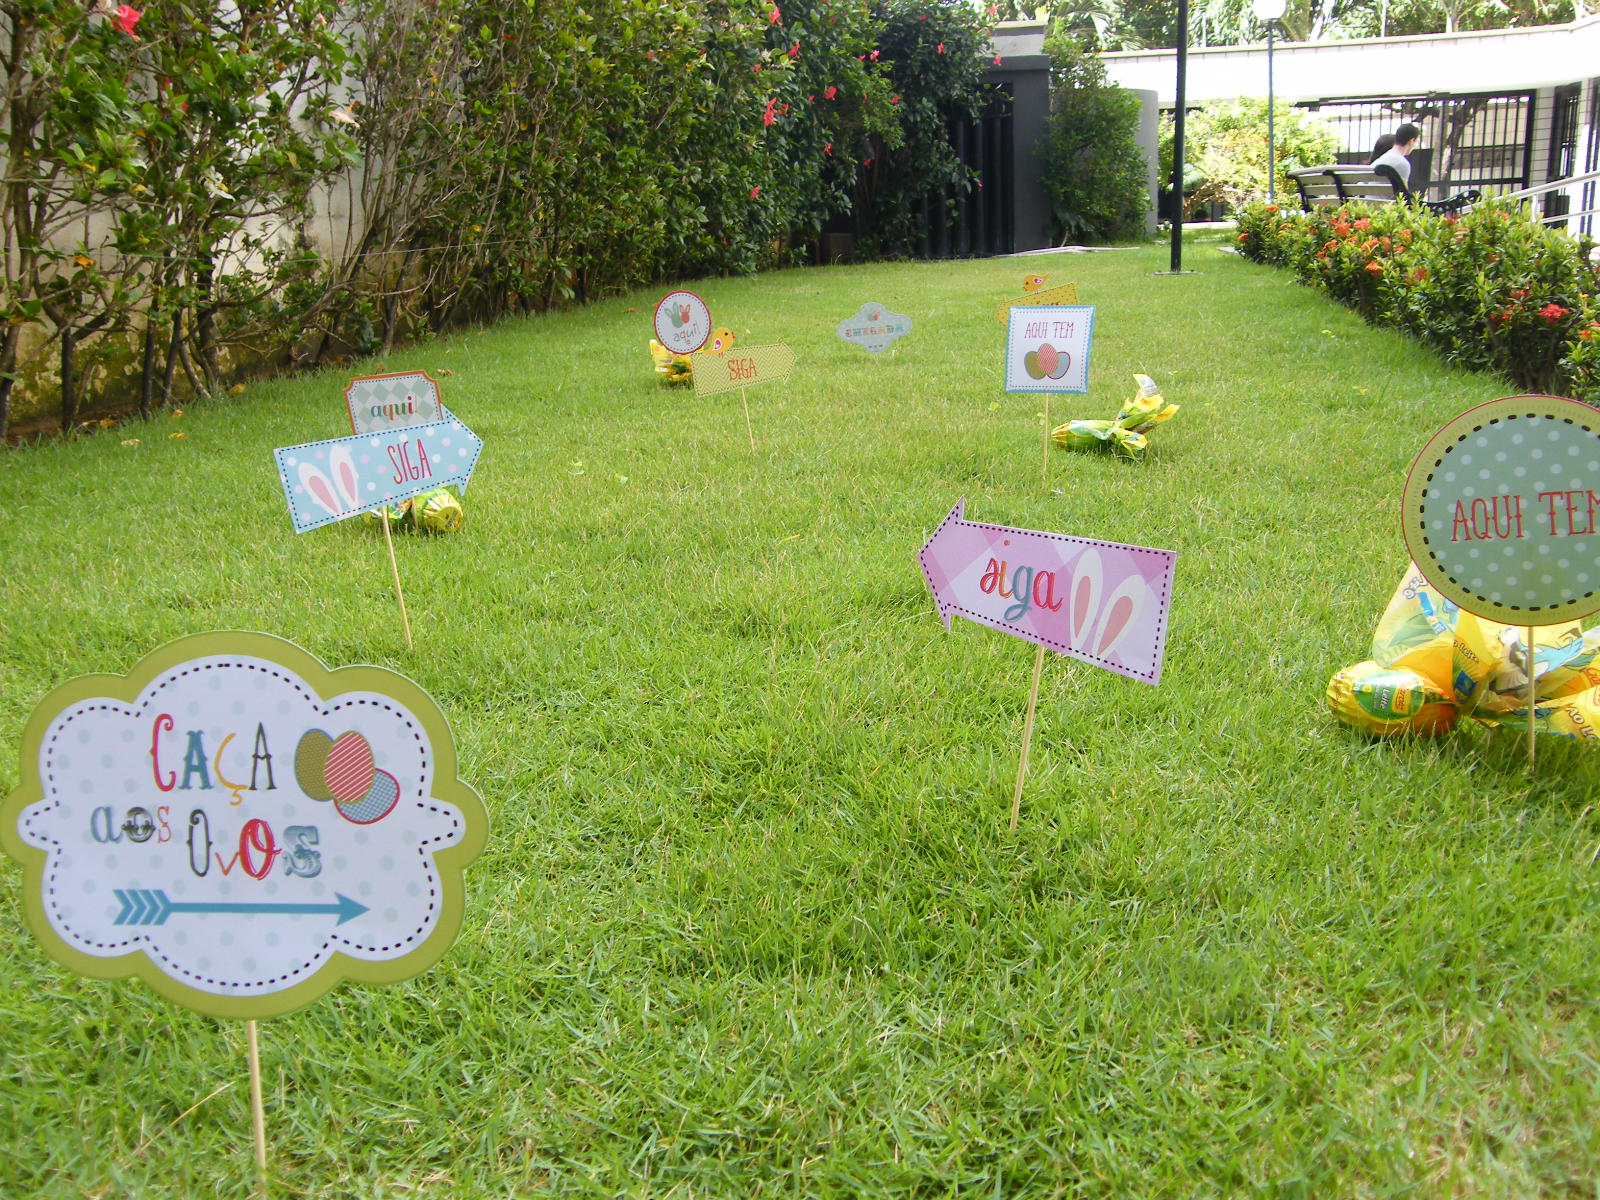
(917, 499, 1178, 683)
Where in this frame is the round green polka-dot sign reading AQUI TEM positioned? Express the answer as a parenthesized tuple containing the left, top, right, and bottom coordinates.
(1402, 395, 1600, 626)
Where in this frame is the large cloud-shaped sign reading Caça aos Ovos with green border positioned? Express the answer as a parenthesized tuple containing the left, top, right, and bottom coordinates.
(0, 634, 486, 1018)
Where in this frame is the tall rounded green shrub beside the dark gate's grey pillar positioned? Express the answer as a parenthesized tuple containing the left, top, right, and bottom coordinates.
(1045, 37, 1150, 242)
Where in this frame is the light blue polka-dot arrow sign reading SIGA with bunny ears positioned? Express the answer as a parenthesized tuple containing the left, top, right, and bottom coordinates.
(272, 410, 483, 533)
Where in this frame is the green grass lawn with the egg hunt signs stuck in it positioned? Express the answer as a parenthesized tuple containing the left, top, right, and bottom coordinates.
(0, 243, 1600, 1200)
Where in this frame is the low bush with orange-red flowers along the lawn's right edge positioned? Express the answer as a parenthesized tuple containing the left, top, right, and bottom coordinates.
(1238, 202, 1600, 405)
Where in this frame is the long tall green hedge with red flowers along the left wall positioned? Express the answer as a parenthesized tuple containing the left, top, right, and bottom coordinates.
(0, 0, 989, 445)
